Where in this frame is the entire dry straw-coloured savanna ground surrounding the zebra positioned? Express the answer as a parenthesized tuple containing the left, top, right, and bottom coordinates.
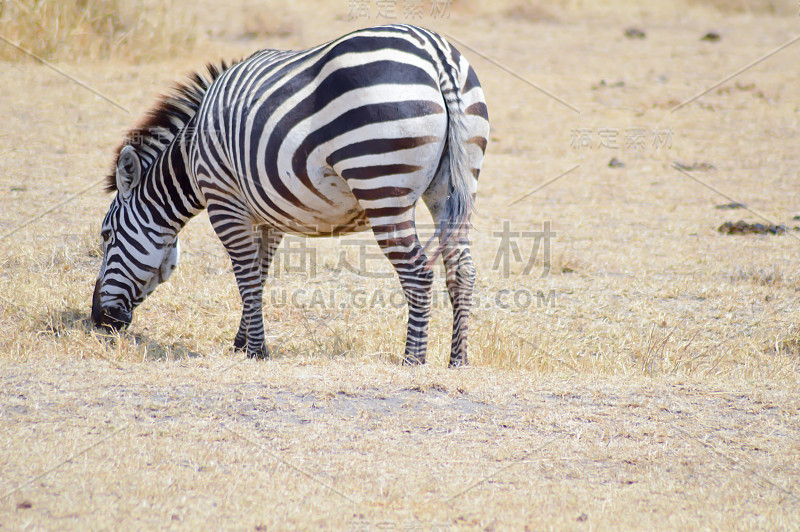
(0, 0, 800, 530)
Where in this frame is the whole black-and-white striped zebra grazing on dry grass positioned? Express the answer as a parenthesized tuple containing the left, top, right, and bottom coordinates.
(92, 25, 489, 366)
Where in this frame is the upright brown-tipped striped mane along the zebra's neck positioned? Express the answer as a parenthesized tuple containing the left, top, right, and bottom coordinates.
(105, 61, 239, 192)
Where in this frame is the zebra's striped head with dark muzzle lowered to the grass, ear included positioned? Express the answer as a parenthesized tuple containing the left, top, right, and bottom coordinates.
(92, 146, 180, 330)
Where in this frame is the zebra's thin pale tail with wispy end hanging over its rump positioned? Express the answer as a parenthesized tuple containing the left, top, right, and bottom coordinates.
(425, 72, 475, 267)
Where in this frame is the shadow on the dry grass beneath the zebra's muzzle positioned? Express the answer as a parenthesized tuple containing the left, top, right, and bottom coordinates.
(41, 307, 202, 362)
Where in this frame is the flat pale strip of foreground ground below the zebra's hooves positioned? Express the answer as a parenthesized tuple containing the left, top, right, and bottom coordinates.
(0, 358, 800, 530)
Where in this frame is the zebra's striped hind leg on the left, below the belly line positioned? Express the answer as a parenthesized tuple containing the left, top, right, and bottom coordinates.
(367, 215, 433, 365)
